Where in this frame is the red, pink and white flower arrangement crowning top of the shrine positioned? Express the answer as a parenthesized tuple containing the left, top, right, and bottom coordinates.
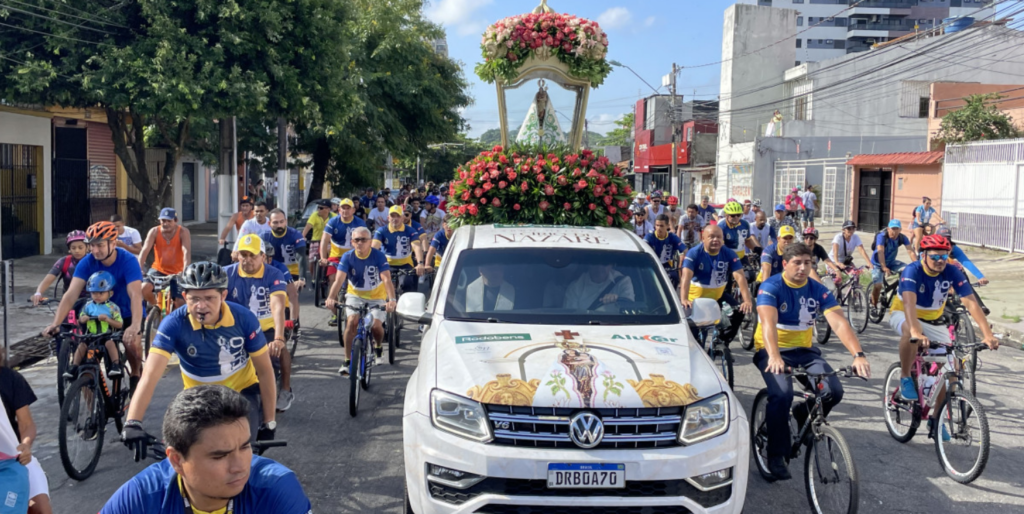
(476, 12, 611, 87)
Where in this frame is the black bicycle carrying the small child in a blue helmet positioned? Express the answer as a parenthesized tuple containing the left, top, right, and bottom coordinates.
(57, 331, 131, 481)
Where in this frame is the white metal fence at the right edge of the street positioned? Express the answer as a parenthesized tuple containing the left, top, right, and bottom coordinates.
(942, 139, 1024, 252)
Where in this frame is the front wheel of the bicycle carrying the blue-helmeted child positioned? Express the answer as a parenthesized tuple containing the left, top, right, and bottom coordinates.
(57, 375, 106, 480)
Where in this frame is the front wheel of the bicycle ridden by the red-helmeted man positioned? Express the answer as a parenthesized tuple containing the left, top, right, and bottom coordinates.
(935, 391, 989, 483)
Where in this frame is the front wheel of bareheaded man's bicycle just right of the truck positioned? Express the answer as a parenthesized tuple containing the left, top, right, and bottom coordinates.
(804, 425, 859, 514)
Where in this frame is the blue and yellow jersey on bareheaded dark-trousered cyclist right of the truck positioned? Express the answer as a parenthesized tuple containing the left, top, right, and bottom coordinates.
(754, 273, 840, 351)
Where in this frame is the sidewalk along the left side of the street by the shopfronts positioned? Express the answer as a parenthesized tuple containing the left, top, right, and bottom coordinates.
(0, 223, 219, 367)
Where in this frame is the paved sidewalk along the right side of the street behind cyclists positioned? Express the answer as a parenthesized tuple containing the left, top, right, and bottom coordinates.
(817, 221, 1024, 349)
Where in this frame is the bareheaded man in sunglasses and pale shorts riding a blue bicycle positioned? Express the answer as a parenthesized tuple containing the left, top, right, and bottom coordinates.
(327, 226, 395, 377)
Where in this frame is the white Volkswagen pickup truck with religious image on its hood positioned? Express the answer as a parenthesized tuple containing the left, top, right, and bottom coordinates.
(398, 225, 750, 514)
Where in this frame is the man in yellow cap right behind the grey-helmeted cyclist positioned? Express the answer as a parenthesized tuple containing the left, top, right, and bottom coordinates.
(224, 233, 295, 412)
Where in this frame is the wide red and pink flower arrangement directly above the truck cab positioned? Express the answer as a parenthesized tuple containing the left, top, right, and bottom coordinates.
(447, 142, 633, 227)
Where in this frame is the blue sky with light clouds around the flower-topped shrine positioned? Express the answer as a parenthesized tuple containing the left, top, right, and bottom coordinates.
(424, 0, 735, 137)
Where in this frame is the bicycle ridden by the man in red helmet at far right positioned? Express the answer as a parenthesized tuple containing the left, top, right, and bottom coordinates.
(882, 339, 990, 483)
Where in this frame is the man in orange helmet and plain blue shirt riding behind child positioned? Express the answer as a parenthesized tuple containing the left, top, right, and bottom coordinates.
(42, 221, 145, 391)
